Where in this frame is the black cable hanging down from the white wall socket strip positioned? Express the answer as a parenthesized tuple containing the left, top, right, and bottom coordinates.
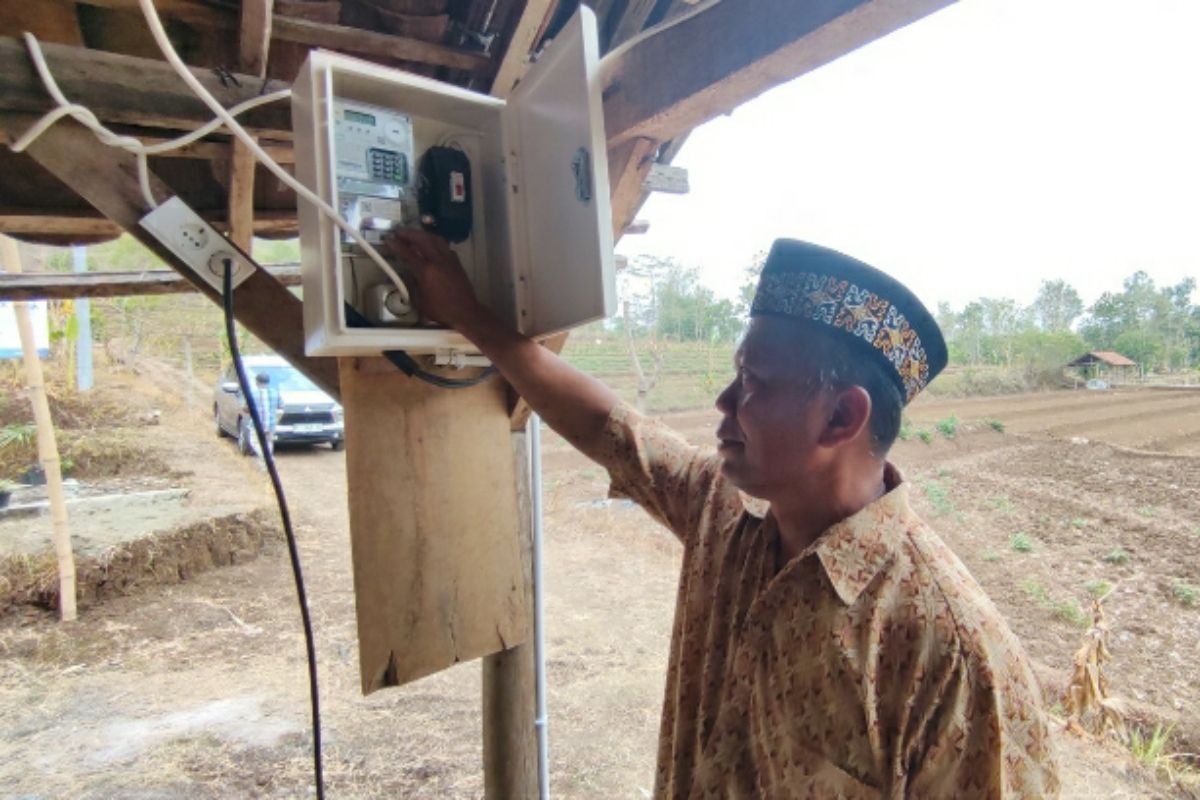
(221, 259, 325, 800)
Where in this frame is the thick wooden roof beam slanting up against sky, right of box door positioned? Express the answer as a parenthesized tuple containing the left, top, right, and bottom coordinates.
(602, 0, 953, 145)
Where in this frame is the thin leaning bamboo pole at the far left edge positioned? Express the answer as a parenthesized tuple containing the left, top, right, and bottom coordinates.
(0, 235, 76, 622)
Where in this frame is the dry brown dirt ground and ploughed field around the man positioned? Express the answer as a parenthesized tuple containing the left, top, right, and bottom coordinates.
(0, 381, 1200, 799)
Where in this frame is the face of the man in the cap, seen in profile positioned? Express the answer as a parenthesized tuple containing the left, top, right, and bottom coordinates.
(716, 317, 829, 500)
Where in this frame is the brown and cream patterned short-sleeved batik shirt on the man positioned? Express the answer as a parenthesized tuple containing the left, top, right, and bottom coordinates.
(601, 405, 1058, 799)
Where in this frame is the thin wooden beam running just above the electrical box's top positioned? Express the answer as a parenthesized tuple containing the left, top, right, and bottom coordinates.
(272, 14, 492, 72)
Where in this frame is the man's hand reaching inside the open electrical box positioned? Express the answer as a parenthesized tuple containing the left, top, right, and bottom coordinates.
(383, 228, 481, 330)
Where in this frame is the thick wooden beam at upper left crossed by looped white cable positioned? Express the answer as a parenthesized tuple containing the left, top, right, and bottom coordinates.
(0, 37, 292, 142)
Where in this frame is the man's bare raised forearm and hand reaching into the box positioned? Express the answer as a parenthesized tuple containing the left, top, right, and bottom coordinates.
(386, 229, 617, 458)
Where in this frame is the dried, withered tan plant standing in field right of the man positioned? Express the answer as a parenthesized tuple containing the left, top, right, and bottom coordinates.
(1063, 589, 1128, 741)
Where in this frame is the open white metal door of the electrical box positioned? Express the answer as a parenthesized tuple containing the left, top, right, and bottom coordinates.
(505, 6, 617, 336)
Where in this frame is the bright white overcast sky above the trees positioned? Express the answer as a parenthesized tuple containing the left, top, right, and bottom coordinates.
(618, 0, 1200, 308)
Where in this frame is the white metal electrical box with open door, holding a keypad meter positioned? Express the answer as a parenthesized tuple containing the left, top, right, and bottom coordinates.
(292, 6, 616, 355)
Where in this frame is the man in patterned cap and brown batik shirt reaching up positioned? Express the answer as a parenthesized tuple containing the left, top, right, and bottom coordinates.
(390, 231, 1057, 798)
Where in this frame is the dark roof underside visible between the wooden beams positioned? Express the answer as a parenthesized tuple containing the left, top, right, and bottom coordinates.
(0, 0, 694, 245)
